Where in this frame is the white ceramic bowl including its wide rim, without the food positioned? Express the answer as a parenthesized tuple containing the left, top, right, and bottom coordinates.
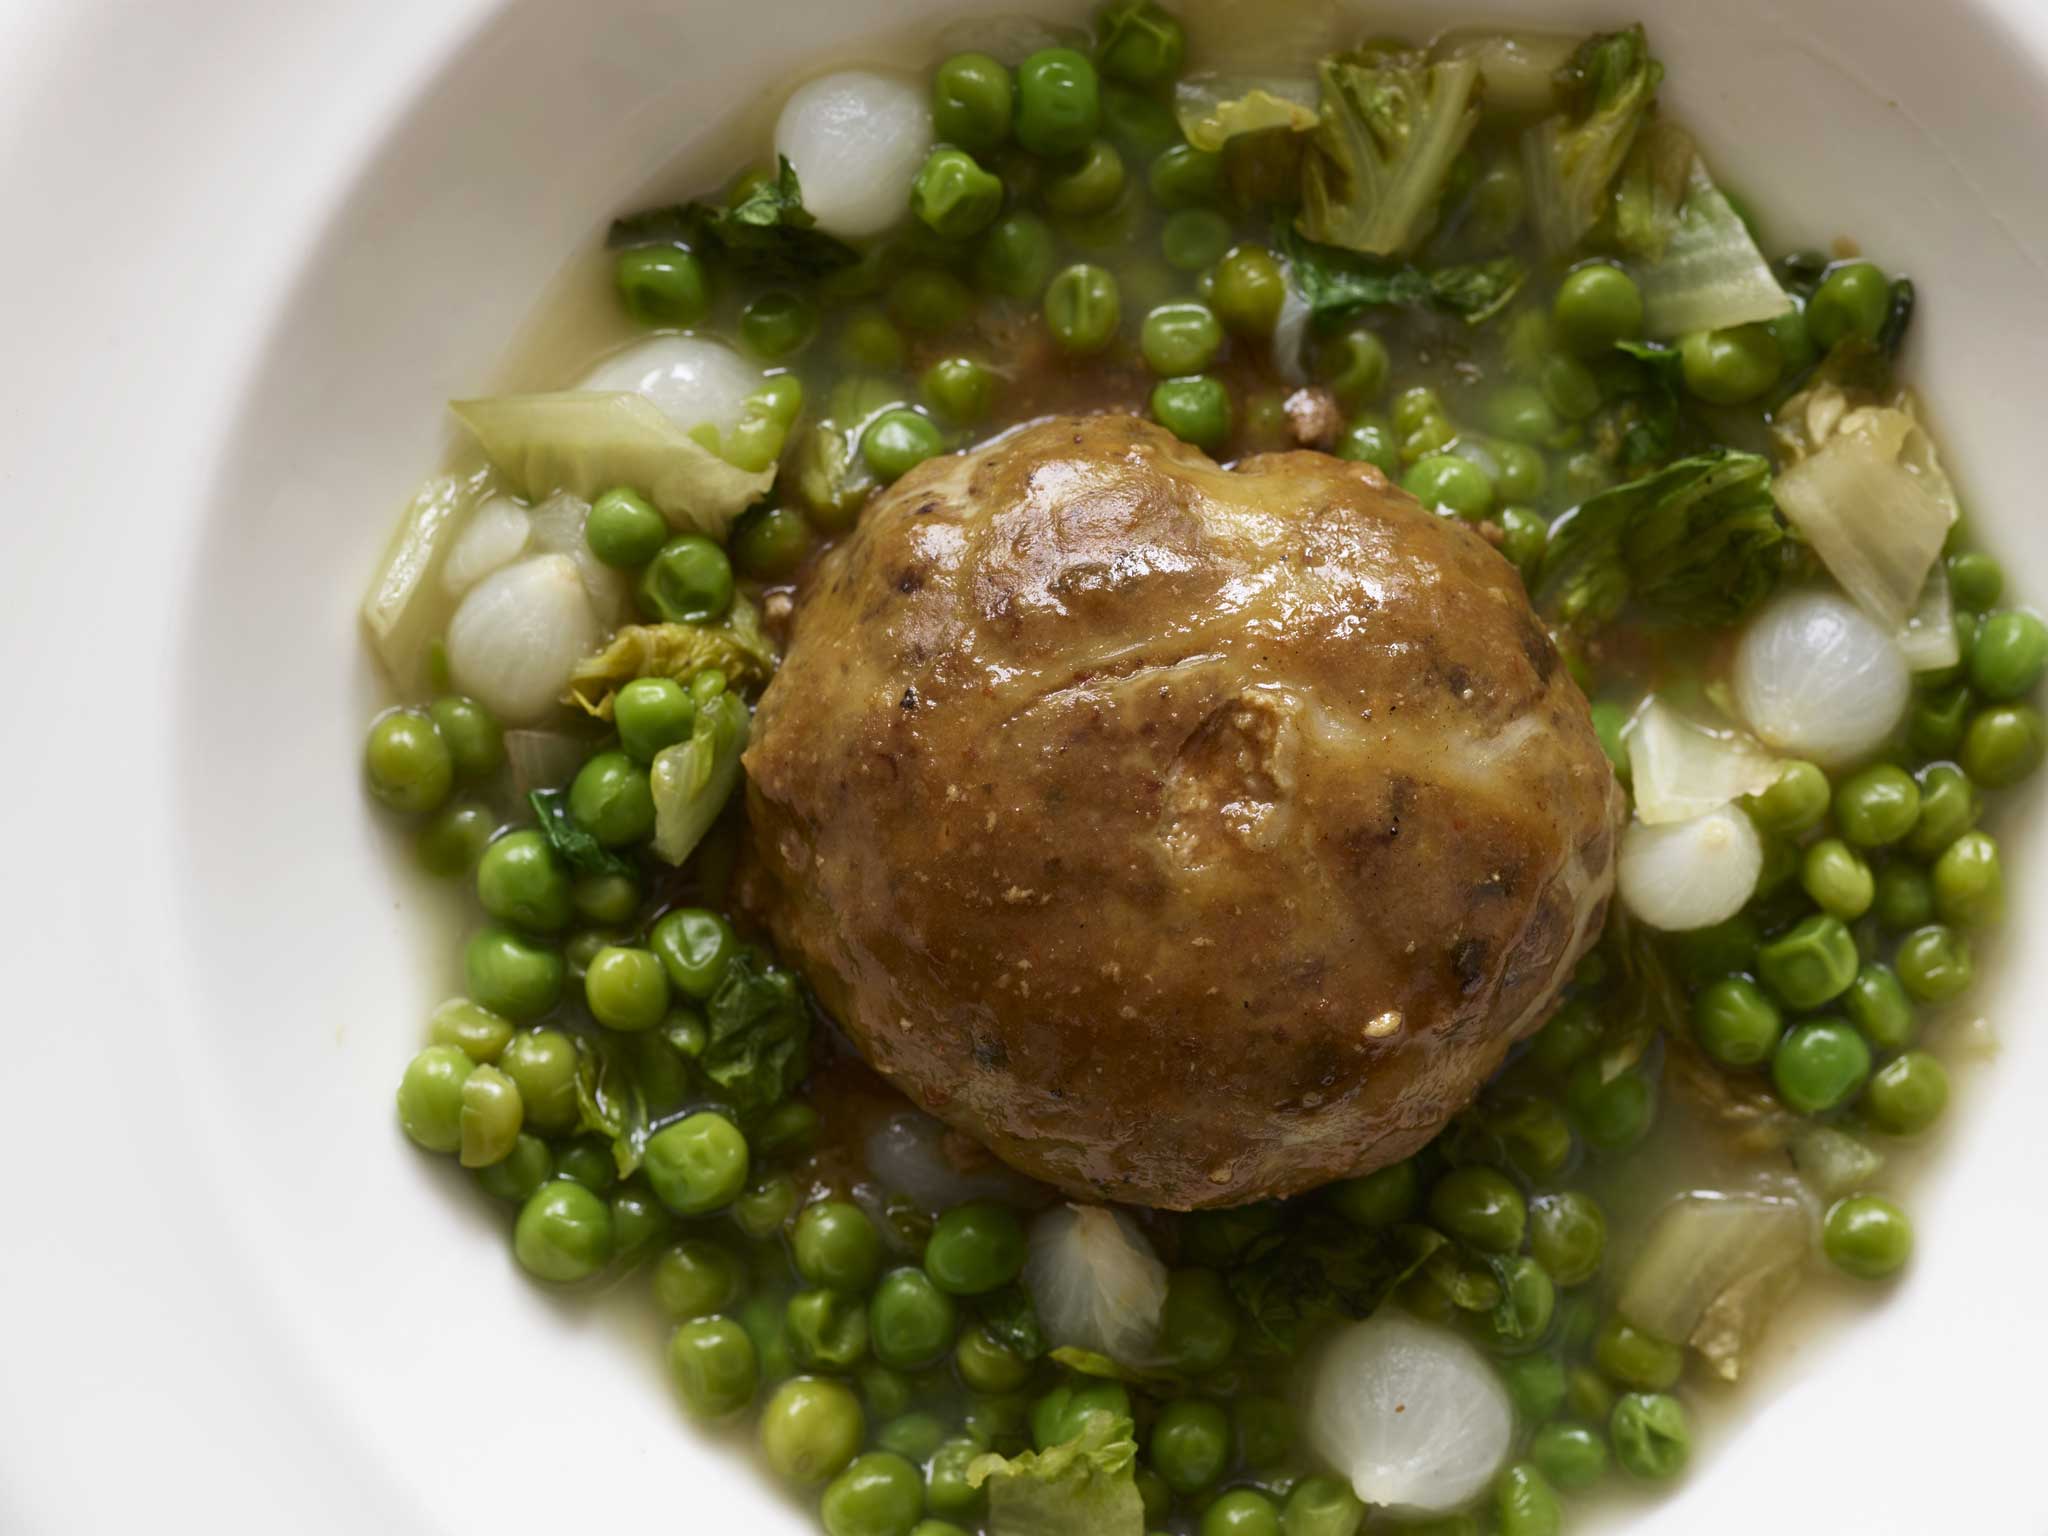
(0, 0, 2048, 1536)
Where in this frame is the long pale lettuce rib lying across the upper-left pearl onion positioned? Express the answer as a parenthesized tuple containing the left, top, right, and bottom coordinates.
(453, 389, 774, 541)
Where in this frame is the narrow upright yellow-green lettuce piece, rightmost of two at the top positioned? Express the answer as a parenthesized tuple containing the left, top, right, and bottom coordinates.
(1522, 25, 1663, 258)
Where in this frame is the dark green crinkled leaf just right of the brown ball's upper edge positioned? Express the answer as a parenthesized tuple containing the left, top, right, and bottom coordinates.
(1536, 449, 1786, 629)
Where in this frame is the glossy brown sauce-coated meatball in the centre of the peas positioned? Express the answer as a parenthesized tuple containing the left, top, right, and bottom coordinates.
(745, 416, 1622, 1208)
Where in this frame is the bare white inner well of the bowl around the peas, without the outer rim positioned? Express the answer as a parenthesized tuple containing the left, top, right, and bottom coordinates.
(168, 0, 2048, 1536)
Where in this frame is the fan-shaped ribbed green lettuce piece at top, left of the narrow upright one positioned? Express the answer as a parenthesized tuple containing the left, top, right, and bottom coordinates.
(1298, 51, 1479, 256)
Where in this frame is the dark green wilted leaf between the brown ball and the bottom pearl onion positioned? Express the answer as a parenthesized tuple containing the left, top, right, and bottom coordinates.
(1229, 1212, 1444, 1354)
